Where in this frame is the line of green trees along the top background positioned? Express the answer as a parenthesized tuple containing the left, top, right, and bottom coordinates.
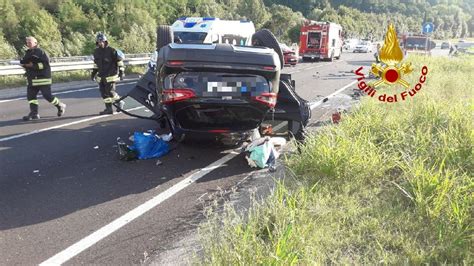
(0, 0, 474, 59)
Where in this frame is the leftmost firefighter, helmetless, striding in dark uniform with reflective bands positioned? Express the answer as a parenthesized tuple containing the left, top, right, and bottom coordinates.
(20, 36, 66, 121)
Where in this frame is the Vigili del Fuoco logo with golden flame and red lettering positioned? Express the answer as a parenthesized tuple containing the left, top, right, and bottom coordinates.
(355, 24, 428, 103)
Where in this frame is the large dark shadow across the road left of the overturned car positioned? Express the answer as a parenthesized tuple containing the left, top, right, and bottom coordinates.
(0, 119, 231, 230)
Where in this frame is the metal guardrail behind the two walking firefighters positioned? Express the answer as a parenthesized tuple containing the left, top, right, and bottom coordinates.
(0, 54, 151, 76)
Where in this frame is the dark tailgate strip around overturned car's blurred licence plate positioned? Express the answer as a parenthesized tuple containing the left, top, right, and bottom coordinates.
(164, 72, 270, 96)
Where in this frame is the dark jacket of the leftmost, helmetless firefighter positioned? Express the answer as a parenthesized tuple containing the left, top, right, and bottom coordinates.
(20, 47, 52, 86)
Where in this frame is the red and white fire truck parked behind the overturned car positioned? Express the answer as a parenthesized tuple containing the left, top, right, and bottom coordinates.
(300, 20, 342, 61)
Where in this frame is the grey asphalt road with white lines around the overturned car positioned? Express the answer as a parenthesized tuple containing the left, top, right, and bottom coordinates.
(0, 50, 373, 265)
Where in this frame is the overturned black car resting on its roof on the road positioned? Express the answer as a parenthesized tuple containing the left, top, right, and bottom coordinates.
(117, 27, 311, 141)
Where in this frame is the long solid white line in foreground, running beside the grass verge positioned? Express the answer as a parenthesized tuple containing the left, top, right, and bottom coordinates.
(40, 152, 239, 265)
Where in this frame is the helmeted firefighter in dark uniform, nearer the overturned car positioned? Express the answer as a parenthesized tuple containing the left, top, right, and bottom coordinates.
(91, 33, 124, 115)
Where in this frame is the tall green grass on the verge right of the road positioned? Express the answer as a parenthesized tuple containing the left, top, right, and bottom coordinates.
(201, 54, 474, 265)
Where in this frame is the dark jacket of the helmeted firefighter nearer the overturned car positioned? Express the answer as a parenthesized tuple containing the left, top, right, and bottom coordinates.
(92, 46, 124, 82)
